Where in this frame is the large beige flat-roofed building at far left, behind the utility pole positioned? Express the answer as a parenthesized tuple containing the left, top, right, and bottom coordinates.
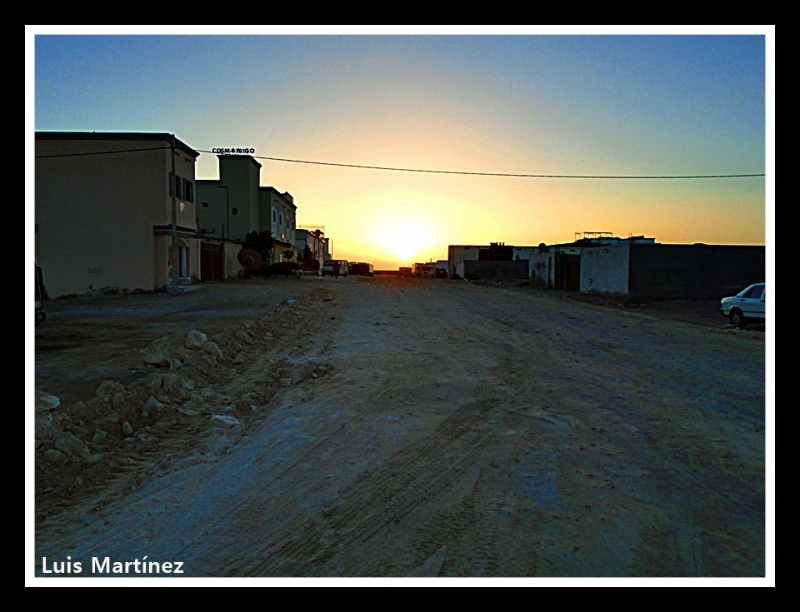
(35, 132, 200, 297)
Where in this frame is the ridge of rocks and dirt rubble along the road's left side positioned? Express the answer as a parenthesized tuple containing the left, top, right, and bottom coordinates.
(35, 293, 326, 519)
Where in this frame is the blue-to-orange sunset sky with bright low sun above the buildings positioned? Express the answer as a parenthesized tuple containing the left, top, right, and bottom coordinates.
(27, 26, 774, 269)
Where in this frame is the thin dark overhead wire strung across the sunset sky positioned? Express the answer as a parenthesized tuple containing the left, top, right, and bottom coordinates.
(36, 147, 766, 180)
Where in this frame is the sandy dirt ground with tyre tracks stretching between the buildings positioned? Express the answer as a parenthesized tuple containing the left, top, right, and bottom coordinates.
(31, 278, 766, 576)
